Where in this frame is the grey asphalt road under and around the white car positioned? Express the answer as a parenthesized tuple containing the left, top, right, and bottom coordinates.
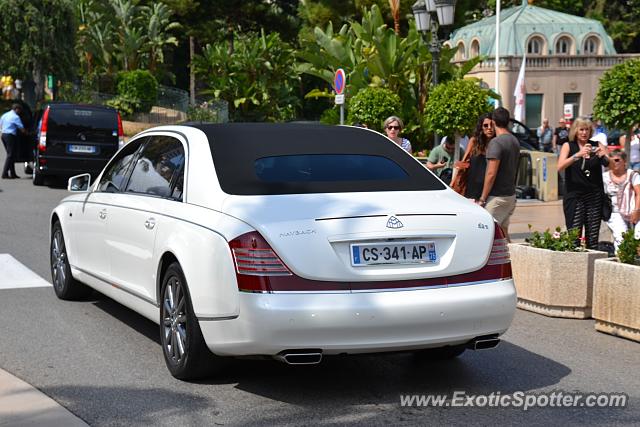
(0, 151, 640, 426)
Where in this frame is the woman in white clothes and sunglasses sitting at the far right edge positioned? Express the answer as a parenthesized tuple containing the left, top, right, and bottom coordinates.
(602, 149, 640, 251)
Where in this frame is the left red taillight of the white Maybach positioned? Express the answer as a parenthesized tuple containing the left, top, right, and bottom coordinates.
(229, 231, 291, 292)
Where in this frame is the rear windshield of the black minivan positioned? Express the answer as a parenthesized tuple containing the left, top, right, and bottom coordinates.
(47, 106, 118, 142)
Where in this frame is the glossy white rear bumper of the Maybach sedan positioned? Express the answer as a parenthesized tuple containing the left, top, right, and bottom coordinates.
(200, 279, 516, 356)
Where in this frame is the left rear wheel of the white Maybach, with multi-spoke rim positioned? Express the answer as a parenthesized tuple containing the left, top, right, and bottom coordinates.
(160, 262, 220, 380)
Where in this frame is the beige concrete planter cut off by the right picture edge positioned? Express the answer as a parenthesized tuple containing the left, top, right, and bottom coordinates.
(593, 258, 640, 342)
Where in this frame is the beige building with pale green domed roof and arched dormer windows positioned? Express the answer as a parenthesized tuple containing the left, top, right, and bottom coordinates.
(445, 0, 638, 128)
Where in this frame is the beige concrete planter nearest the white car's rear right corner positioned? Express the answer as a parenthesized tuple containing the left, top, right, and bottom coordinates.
(509, 243, 607, 319)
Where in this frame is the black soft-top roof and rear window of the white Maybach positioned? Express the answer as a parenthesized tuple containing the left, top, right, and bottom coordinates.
(196, 123, 445, 195)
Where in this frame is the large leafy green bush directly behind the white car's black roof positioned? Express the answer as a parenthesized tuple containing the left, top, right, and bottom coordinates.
(194, 32, 300, 122)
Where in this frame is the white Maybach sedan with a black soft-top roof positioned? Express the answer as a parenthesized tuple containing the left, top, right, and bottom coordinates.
(50, 123, 516, 379)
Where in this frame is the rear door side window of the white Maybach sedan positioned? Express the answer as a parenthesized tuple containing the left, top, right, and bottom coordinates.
(126, 136, 184, 197)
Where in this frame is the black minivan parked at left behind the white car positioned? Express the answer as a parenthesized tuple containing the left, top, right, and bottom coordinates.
(32, 103, 124, 185)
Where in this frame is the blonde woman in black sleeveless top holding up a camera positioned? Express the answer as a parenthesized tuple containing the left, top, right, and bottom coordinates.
(558, 118, 609, 249)
